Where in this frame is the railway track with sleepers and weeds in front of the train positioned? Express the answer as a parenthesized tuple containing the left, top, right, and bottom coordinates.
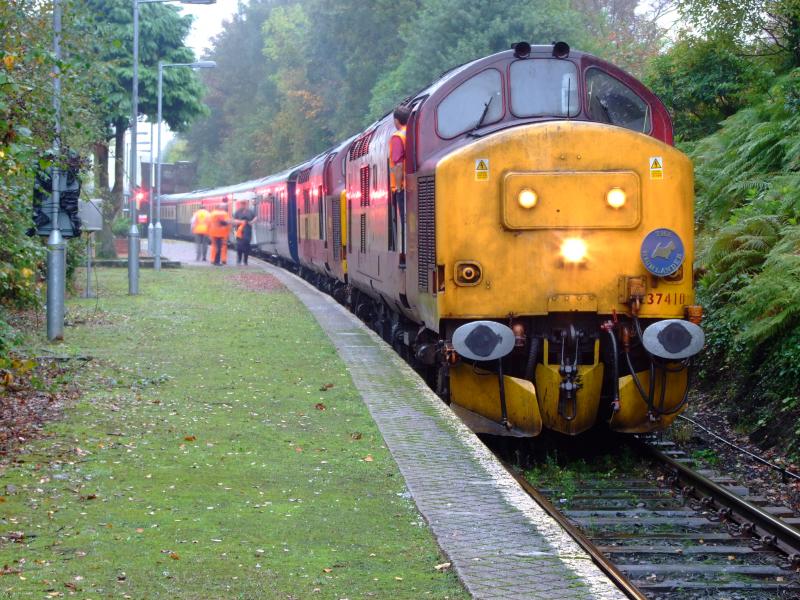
(504, 440, 800, 600)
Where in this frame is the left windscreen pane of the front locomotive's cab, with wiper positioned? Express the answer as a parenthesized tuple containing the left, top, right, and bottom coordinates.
(436, 69, 503, 139)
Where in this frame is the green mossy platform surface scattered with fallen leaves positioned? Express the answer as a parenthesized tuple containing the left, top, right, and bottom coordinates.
(0, 269, 466, 599)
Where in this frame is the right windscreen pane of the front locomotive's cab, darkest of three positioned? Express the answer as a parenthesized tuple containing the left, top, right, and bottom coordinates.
(586, 68, 652, 133)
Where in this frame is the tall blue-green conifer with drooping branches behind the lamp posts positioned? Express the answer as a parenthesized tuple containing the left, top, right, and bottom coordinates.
(84, 0, 204, 254)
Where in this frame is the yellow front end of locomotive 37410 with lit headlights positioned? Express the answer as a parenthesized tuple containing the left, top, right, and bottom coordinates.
(434, 121, 702, 435)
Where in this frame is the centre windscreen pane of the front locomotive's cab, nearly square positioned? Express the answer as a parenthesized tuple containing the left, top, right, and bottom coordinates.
(510, 59, 580, 117)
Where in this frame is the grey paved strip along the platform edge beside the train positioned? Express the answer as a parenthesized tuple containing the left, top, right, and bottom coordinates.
(163, 240, 626, 600)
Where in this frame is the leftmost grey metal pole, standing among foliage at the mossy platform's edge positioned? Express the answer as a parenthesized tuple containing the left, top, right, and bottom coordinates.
(47, 0, 67, 341)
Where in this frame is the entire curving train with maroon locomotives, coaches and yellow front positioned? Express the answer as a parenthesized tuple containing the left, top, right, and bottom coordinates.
(162, 42, 704, 436)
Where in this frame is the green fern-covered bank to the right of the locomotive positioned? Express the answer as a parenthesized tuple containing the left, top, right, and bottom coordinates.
(693, 69, 800, 445)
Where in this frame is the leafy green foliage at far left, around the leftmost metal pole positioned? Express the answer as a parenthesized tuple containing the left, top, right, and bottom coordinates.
(0, 0, 107, 353)
